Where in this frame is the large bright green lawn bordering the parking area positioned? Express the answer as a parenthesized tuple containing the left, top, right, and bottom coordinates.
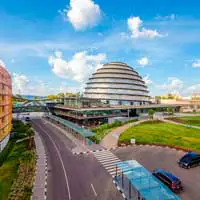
(119, 121, 200, 151)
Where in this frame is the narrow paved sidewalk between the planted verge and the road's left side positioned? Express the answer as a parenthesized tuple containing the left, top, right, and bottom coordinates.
(32, 132, 47, 200)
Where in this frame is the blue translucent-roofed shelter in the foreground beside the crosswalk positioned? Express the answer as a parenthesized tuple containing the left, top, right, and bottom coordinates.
(115, 160, 181, 200)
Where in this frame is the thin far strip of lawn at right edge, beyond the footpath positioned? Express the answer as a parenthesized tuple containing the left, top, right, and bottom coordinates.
(169, 116, 200, 126)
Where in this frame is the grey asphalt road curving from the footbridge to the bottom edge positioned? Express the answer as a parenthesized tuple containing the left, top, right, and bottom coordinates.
(32, 120, 123, 200)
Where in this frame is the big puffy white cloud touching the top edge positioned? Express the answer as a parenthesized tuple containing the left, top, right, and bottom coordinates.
(60, 0, 101, 30)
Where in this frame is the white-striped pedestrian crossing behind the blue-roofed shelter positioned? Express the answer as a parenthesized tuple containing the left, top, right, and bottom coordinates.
(94, 151, 121, 177)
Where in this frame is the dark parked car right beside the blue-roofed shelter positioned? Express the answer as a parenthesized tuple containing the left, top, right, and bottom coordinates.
(152, 169, 183, 193)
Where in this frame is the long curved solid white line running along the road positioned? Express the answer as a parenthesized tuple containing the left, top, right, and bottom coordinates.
(33, 124, 71, 200)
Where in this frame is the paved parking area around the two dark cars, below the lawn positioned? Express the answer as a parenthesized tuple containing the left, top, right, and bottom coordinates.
(113, 146, 200, 200)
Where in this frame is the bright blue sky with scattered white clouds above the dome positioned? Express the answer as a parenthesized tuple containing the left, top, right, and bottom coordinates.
(0, 0, 200, 96)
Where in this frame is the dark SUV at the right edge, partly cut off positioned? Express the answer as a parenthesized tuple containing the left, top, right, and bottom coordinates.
(178, 152, 200, 169)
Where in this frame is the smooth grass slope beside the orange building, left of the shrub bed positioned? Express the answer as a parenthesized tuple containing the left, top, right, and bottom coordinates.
(0, 142, 26, 200)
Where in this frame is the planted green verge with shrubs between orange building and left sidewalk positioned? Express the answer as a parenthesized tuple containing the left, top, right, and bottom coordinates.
(0, 121, 36, 200)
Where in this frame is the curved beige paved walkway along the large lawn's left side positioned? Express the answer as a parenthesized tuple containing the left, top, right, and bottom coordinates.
(101, 120, 148, 149)
